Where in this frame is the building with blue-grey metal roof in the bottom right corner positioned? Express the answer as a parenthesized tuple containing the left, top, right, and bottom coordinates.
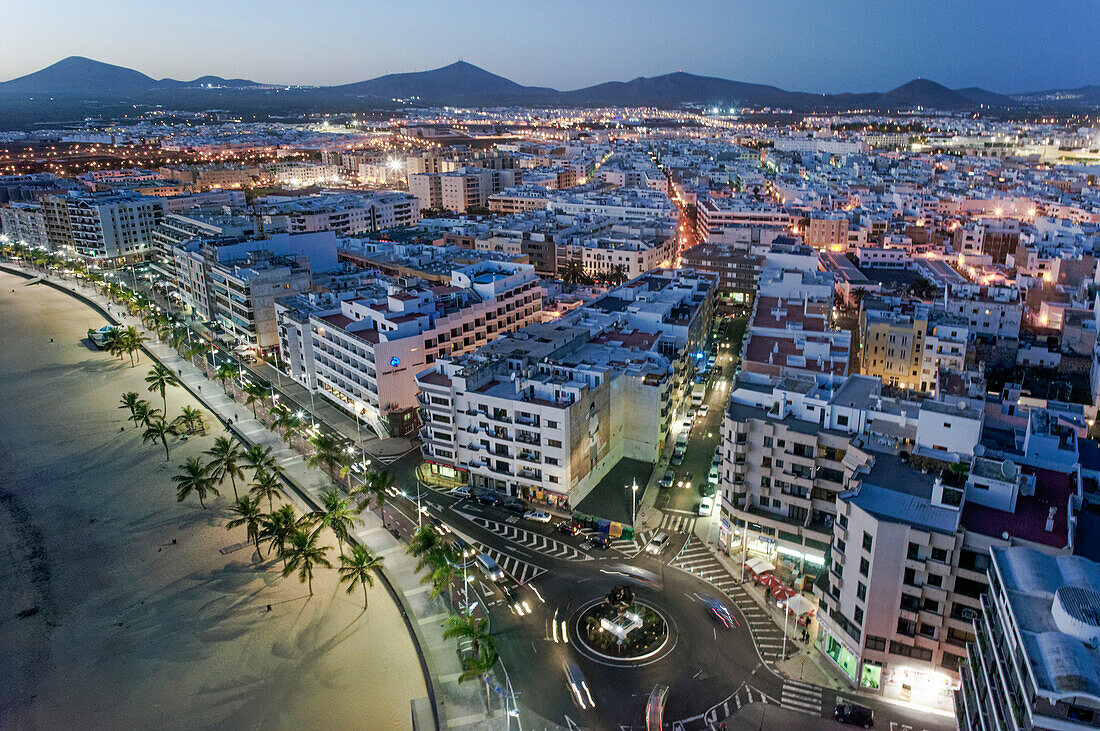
(955, 546, 1100, 731)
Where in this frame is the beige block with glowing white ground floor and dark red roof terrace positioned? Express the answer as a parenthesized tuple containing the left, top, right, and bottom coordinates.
(814, 402, 1081, 707)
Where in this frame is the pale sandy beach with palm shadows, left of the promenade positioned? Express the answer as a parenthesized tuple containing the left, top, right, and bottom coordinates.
(0, 273, 427, 730)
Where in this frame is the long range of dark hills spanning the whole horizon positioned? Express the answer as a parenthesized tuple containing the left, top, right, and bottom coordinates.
(0, 56, 1100, 124)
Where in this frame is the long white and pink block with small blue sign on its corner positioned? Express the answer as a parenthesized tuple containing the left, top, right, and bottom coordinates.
(277, 262, 542, 435)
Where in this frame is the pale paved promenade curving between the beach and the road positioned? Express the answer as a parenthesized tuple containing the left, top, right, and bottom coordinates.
(15, 265, 530, 729)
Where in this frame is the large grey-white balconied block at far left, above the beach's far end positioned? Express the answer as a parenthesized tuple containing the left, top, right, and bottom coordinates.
(42, 192, 164, 263)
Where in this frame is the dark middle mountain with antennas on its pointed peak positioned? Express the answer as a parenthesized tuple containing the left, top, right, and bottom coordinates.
(329, 60, 558, 103)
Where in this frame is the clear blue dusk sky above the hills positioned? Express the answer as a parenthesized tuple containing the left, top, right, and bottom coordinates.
(0, 0, 1100, 93)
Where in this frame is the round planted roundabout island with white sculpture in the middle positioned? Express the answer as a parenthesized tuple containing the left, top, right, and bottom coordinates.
(573, 586, 675, 665)
